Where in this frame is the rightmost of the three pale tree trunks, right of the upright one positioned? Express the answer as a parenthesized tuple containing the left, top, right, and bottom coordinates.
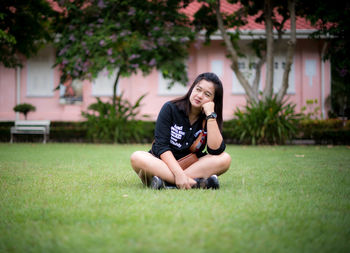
(277, 0, 296, 102)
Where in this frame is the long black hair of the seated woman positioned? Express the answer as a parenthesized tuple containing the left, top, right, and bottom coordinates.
(172, 72, 224, 131)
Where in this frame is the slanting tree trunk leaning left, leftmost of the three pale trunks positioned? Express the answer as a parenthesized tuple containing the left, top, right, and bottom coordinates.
(215, 0, 259, 102)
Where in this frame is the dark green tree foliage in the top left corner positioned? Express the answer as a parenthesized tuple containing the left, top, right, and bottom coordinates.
(0, 0, 56, 68)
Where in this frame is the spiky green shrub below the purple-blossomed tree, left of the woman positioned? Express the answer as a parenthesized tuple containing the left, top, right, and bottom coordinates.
(82, 95, 150, 143)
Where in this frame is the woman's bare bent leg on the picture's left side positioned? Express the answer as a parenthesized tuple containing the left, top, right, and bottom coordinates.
(130, 151, 175, 185)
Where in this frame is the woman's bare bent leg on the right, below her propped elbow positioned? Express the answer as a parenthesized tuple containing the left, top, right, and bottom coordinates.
(185, 152, 231, 178)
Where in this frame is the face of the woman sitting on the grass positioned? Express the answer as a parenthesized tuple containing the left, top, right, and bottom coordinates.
(190, 80, 215, 108)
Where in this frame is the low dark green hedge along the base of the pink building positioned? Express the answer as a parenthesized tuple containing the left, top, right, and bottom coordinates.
(0, 119, 350, 145)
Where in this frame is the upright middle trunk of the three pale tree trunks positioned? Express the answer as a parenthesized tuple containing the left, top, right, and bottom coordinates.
(263, 0, 274, 100)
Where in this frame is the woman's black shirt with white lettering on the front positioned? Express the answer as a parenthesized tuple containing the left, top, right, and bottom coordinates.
(151, 102, 226, 159)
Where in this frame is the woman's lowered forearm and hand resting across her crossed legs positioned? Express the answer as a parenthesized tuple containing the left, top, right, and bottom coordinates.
(160, 151, 196, 189)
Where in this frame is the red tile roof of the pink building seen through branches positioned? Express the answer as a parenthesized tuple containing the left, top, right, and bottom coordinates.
(184, 0, 316, 30)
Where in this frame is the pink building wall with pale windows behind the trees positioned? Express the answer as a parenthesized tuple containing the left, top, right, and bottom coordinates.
(0, 40, 330, 121)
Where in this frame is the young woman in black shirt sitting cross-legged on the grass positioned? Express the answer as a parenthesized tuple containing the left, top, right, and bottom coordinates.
(130, 73, 231, 189)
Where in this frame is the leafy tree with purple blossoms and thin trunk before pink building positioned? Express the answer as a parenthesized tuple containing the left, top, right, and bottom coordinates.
(56, 0, 194, 105)
